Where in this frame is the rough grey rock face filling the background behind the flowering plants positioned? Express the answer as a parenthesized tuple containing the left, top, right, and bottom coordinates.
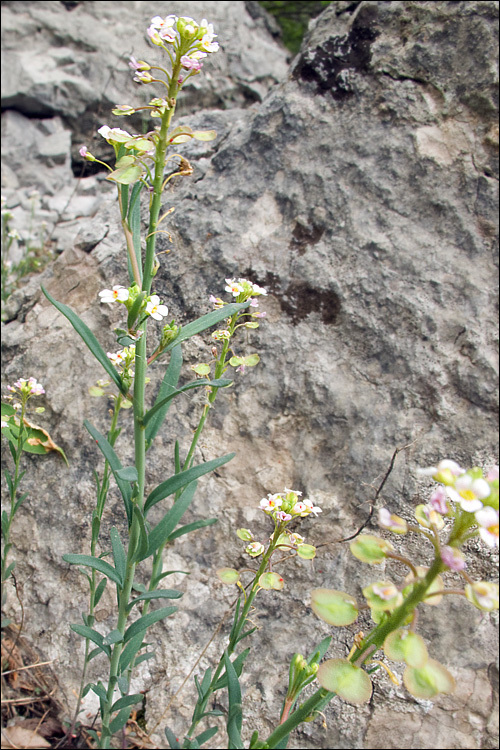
(2, 2, 498, 748)
